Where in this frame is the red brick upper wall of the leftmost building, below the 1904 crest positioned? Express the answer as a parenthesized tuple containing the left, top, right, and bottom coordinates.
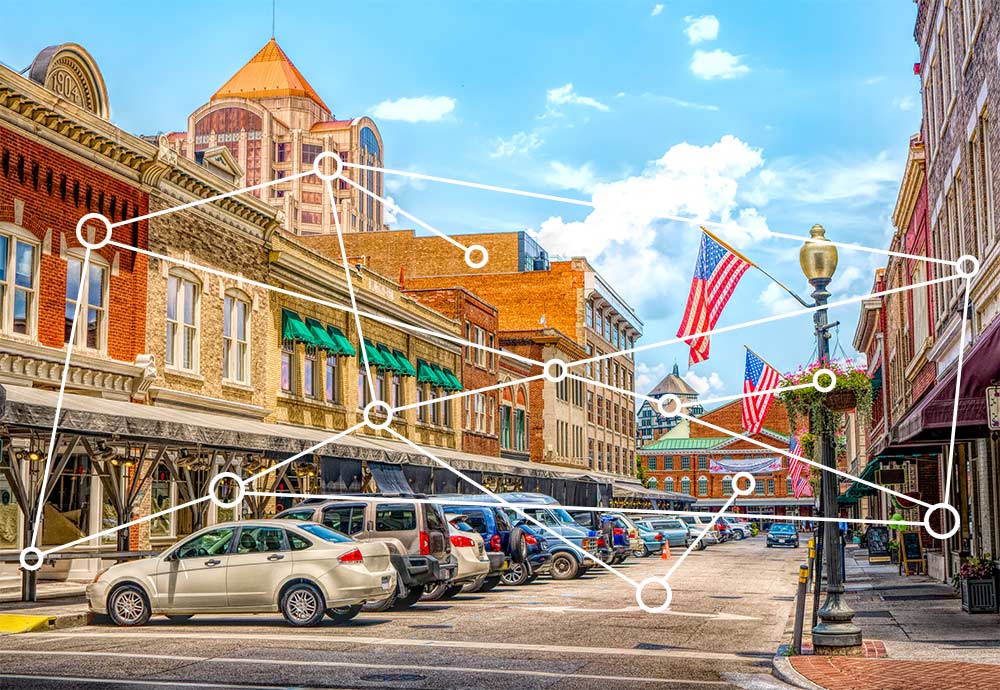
(0, 127, 148, 362)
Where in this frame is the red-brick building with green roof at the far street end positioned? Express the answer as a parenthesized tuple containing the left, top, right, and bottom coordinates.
(638, 400, 815, 515)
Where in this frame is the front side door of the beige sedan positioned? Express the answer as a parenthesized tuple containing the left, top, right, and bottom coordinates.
(154, 526, 236, 611)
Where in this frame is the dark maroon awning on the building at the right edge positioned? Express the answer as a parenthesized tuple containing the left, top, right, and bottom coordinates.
(894, 319, 1000, 442)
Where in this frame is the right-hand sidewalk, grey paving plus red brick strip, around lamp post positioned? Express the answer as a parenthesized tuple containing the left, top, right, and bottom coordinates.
(775, 546, 1000, 690)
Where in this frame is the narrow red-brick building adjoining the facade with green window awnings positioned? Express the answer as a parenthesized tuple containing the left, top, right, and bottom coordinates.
(403, 287, 500, 457)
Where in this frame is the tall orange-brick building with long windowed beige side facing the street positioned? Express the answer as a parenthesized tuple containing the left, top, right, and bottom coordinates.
(303, 230, 642, 477)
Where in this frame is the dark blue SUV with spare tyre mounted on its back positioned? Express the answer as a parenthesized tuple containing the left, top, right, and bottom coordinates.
(434, 494, 552, 592)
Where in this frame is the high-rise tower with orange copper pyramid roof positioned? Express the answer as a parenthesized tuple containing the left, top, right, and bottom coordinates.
(167, 37, 386, 235)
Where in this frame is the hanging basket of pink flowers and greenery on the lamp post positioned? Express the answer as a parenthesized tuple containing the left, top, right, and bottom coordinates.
(778, 358, 873, 432)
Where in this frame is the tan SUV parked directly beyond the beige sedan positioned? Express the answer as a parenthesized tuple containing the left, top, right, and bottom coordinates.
(276, 495, 458, 611)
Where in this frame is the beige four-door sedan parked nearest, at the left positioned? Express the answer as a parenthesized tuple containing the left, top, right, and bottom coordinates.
(87, 520, 396, 626)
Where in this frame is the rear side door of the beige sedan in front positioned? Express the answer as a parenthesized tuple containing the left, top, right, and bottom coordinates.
(226, 525, 292, 609)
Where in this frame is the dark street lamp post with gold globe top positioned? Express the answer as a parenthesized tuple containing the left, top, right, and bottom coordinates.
(799, 225, 861, 654)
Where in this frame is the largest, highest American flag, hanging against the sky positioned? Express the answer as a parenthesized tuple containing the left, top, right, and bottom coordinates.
(677, 228, 752, 364)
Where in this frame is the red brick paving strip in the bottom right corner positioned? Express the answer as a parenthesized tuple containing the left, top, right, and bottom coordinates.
(791, 656, 1000, 690)
